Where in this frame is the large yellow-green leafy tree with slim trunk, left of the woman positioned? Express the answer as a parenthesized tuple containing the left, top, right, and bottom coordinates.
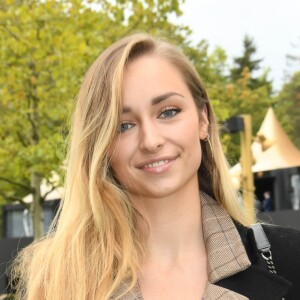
(0, 0, 188, 238)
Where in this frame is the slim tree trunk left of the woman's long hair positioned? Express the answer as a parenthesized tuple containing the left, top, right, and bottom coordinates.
(31, 172, 44, 240)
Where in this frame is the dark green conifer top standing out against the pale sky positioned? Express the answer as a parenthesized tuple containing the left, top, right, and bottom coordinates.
(230, 35, 272, 93)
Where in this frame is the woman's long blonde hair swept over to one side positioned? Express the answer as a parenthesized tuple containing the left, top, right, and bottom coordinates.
(14, 34, 252, 300)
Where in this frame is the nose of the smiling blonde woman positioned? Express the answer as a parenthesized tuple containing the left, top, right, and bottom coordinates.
(139, 122, 165, 152)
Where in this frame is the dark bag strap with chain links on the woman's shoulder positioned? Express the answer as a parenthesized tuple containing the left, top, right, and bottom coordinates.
(250, 223, 277, 273)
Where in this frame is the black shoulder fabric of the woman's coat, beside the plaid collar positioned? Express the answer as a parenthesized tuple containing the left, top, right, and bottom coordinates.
(215, 222, 300, 300)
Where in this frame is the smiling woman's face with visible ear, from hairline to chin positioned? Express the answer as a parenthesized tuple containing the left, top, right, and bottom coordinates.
(110, 56, 208, 198)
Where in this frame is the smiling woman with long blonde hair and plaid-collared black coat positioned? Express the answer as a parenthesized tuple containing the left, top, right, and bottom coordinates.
(16, 34, 300, 300)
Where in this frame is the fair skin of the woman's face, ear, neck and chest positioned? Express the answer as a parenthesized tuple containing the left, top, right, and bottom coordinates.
(111, 55, 208, 300)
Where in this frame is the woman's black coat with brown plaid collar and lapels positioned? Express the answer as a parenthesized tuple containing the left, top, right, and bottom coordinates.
(112, 193, 300, 300)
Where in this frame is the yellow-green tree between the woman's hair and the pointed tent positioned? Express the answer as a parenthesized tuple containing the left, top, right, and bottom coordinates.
(180, 37, 274, 164)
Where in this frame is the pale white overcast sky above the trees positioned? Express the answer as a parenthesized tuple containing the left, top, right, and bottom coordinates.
(177, 0, 300, 91)
